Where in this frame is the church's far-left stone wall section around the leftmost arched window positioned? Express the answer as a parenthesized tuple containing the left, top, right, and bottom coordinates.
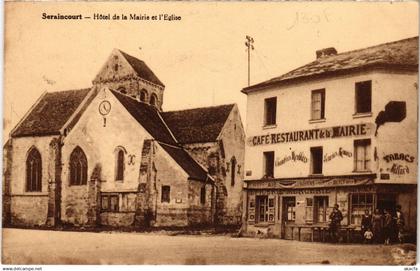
(9, 136, 57, 226)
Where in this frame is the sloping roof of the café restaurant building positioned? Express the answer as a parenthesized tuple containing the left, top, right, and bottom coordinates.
(242, 37, 419, 93)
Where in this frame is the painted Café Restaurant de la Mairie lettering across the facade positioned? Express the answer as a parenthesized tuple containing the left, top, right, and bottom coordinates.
(248, 123, 375, 146)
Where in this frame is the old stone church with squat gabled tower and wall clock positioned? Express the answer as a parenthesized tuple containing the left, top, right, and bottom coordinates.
(3, 49, 245, 228)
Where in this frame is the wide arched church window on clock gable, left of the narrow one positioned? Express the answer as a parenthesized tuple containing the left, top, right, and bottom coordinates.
(70, 146, 87, 185)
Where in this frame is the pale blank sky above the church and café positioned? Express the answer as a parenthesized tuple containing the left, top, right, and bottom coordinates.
(3, 2, 419, 142)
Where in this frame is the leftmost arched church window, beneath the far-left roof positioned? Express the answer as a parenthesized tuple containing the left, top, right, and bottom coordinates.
(26, 147, 42, 192)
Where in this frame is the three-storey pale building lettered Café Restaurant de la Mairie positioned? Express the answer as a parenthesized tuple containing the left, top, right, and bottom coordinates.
(242, 38, 418, 242)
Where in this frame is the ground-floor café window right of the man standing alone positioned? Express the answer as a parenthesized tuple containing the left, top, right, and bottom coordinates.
(350, 193, 374, 225)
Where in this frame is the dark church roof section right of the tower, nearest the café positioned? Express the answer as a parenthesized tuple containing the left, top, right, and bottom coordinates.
(162, 104, 234, 144)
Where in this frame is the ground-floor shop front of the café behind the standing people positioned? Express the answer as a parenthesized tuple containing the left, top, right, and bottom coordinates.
(244, 174, 417, 241)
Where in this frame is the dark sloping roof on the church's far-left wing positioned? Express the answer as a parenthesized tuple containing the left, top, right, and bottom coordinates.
(11, 88, 90, 137)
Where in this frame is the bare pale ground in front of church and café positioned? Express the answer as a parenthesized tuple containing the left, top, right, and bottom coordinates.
(2, 229, 415, 265)
